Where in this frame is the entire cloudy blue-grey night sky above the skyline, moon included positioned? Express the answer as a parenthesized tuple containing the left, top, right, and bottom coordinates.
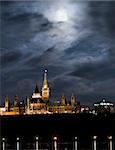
(0, 0, 115, 104)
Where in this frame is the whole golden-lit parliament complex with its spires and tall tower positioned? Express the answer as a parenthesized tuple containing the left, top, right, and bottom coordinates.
(0, 70, 89, 115)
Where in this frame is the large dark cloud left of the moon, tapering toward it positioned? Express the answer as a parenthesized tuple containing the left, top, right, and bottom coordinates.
(1, 2, 53, 51)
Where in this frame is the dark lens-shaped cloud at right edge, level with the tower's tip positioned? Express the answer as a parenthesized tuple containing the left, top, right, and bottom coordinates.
(71, 60, 115, 81)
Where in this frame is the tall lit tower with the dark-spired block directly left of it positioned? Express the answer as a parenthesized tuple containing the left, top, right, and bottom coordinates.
(26, 70, 49, 114)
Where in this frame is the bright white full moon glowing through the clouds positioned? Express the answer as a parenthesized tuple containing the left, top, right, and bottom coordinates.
(55, 9, 68, 22)
